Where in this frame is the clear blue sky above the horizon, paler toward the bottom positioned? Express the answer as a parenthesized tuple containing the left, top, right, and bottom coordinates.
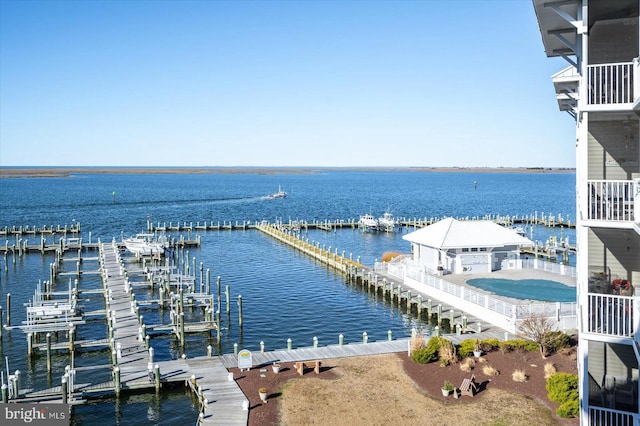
(0, 0, 575, 167)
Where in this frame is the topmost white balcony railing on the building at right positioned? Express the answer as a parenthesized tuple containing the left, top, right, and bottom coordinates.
(587, 61, 637, 105)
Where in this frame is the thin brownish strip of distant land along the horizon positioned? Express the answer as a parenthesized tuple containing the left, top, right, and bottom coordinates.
(0, 166, 576, 178)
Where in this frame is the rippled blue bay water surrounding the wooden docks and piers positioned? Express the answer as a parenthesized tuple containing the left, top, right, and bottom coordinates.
(0, 170, 575, 425)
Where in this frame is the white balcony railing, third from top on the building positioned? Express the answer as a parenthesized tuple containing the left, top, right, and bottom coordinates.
(587, 293, 638, 337)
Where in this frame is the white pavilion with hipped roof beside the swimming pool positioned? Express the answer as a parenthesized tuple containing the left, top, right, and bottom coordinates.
(402, 218, 533, 274)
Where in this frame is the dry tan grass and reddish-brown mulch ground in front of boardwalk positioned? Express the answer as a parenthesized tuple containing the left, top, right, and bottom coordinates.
(230, 348, 579, 426)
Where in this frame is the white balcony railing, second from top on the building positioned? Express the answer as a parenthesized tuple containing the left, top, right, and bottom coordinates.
(587, 180, 640, 222)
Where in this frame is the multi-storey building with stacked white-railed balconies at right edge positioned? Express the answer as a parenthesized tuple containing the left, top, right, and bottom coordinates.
(533, 0, 640, 426)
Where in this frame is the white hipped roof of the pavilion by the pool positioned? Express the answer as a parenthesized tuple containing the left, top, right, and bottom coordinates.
(402, 217, 533, 249)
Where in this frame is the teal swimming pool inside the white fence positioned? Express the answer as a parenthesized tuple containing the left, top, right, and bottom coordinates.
(467, 278, 576, 302)
